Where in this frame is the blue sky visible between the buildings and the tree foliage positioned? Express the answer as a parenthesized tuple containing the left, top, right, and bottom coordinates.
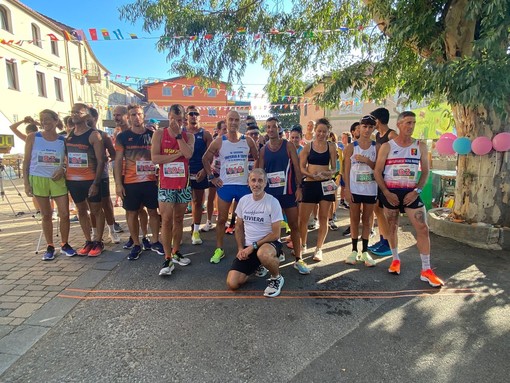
(21, 0, 268, 109)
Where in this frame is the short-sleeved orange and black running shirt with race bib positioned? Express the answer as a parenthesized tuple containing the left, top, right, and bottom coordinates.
(115, 129, 156, 184)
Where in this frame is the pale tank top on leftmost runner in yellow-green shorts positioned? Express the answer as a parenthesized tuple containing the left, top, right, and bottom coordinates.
(29, 132, 65, 178)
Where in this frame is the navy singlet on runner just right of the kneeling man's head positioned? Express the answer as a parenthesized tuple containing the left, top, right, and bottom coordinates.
(264, 140, 296, 196)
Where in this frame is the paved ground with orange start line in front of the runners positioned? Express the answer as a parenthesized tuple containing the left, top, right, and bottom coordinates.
(0, 176, 510, 383)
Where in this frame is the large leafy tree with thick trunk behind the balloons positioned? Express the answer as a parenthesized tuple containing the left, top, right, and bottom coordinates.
(120, 0, 510, 226)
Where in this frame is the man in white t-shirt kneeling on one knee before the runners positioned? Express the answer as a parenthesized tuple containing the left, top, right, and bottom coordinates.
(227, 168, 284, 297)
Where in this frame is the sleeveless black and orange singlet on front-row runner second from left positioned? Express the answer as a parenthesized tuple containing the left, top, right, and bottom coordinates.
(66, 129, 97, 181)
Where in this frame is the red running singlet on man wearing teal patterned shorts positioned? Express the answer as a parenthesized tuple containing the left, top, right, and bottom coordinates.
(159, 128, 189, 190)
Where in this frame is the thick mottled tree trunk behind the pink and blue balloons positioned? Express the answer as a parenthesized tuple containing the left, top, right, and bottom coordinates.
(452, 105, 510, 227)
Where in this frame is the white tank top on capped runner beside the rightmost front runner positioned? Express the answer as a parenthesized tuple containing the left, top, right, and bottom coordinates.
(349, 141, 377, 196)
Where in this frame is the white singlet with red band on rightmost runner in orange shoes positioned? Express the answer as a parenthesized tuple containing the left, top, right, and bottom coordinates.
(384, 140, 421, 189)
